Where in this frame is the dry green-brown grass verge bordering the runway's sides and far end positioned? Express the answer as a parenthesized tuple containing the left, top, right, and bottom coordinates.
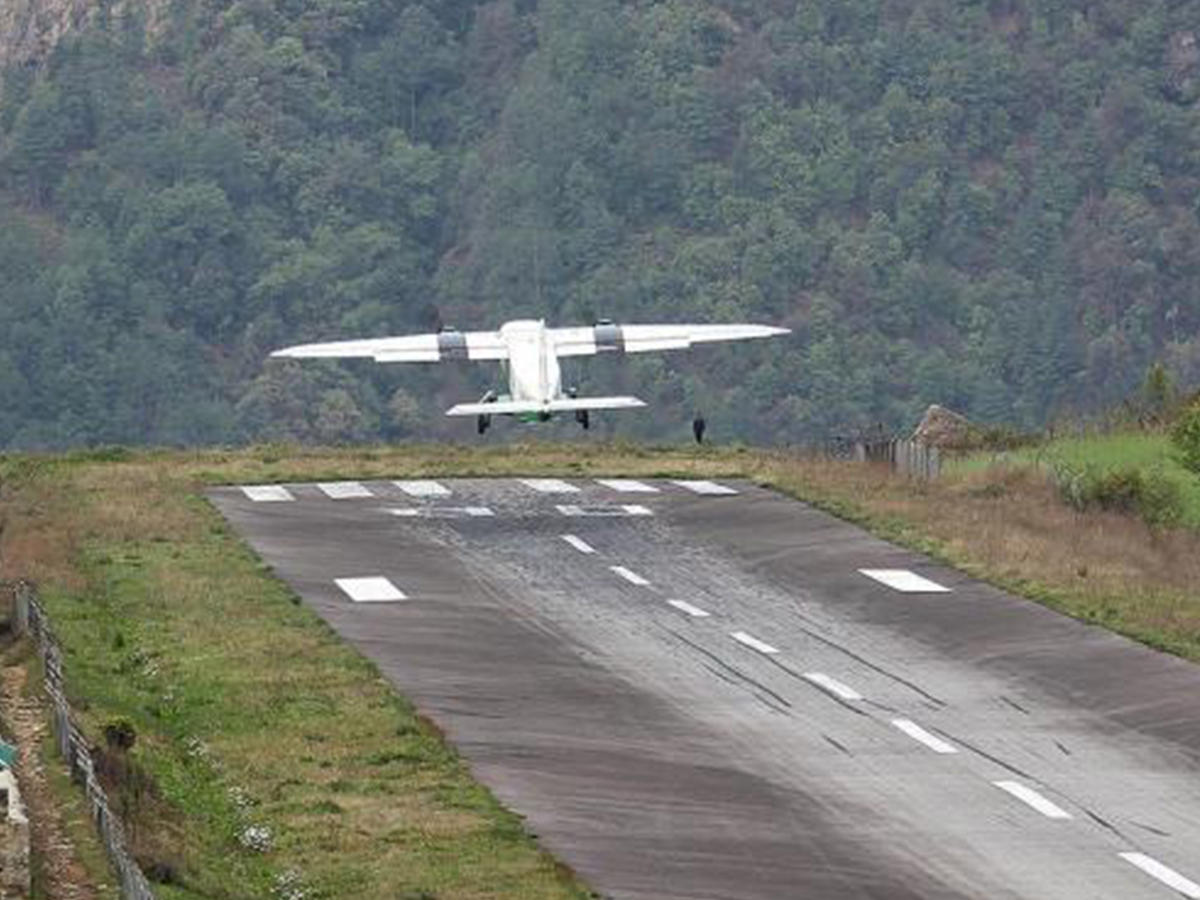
(0, 444, 1200, 900)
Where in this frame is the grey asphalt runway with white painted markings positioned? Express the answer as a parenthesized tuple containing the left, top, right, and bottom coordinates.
(209, 479, 1200, 900)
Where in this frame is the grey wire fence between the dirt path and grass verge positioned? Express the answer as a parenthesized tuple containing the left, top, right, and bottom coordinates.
(13, 582, 154, 900)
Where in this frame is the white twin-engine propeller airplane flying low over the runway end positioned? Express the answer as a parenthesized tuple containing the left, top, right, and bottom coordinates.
(271, 319, 788, 434)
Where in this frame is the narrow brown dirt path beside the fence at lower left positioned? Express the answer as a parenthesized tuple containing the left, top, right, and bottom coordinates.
(0, 665, 101, 900)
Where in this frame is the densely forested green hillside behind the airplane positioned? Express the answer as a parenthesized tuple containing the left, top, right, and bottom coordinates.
(0, 0, 1200, 448)
